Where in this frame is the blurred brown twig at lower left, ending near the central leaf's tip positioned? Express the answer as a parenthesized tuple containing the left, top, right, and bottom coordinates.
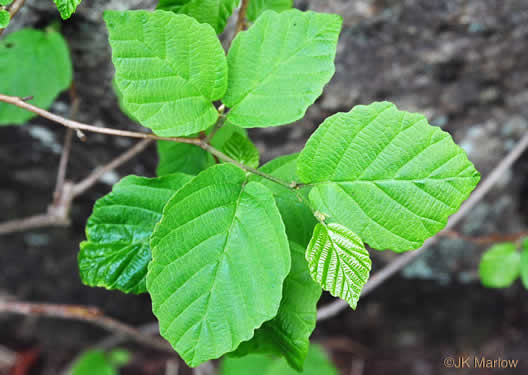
(0, 301, 174, 353)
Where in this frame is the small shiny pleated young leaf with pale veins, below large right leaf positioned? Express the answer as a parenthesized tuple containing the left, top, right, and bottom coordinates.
(306, 223, 372, 309)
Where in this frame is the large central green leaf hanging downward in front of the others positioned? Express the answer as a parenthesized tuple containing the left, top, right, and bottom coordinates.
(147, 164, 290, 367)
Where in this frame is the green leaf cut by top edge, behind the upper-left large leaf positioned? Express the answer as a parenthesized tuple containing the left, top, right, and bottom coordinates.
(158, 0, 240, 34)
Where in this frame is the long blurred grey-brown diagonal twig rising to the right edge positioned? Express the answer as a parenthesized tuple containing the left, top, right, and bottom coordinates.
(317, 133, 528, 320)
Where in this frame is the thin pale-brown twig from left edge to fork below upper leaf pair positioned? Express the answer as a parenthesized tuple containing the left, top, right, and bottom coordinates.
(0, 94, 201, 146)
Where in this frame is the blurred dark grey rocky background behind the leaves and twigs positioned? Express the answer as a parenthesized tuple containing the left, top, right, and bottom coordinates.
(0, 0, 528, 375)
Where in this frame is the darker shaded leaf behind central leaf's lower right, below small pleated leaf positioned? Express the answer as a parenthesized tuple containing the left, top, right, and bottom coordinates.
(234, 241, 321, 371)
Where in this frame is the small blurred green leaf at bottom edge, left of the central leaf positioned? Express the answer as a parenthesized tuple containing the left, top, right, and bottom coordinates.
(71, 349, 130, 375)
